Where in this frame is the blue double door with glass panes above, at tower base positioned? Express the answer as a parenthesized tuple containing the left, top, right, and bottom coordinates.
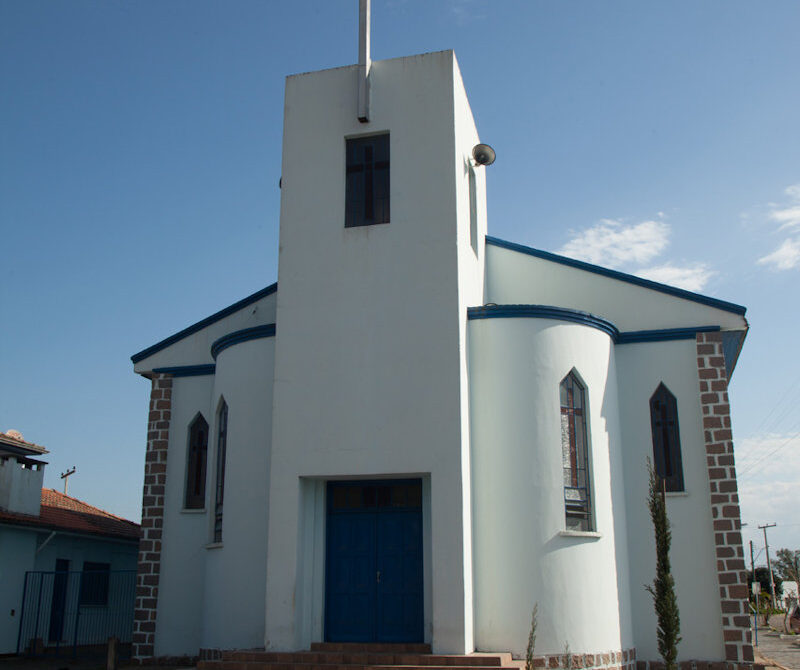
(325, 479, 424, 642)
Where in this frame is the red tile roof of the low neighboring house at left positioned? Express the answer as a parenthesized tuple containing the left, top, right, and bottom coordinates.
(0, 489, 139, 540)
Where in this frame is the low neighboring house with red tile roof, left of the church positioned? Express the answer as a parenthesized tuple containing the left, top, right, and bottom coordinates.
(0, 431, 139, 654)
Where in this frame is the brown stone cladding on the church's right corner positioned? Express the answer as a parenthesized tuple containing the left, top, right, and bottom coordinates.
(696, 332, 753, 670)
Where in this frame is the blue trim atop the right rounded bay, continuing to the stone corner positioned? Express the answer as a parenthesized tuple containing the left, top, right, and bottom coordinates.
(467, 305, 720, 344)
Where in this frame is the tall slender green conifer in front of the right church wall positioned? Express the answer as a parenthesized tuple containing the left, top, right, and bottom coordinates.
(645, 459, 681, 670)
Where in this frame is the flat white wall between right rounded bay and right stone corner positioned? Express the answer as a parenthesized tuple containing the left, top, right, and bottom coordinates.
(617, 340, 725, 660)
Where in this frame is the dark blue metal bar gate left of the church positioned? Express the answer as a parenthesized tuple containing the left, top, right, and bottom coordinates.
(17, 572, 136, 657)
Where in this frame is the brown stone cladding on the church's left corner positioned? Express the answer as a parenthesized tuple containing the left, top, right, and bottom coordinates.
(133, 374, 172, 661)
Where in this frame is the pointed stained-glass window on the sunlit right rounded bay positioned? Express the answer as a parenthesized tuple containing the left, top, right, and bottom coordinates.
(560, 371, 592, 530)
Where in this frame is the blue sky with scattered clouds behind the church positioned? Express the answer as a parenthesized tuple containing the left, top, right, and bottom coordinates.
(0, 0, 800, 559)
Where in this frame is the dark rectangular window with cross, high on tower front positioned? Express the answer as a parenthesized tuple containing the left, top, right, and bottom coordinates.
(344, 135, 389, 228)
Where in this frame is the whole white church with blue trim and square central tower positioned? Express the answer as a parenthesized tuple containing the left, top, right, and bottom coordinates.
(132, 15, 753, 669)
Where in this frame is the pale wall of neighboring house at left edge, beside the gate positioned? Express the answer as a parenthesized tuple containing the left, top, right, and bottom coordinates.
(0, 526, 36, 654)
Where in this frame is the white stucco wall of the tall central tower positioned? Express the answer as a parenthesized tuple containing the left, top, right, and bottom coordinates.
(266, 52, 485, 652)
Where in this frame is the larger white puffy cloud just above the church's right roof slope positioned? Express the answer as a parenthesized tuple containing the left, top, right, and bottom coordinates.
(558, 219, 670, 268)
